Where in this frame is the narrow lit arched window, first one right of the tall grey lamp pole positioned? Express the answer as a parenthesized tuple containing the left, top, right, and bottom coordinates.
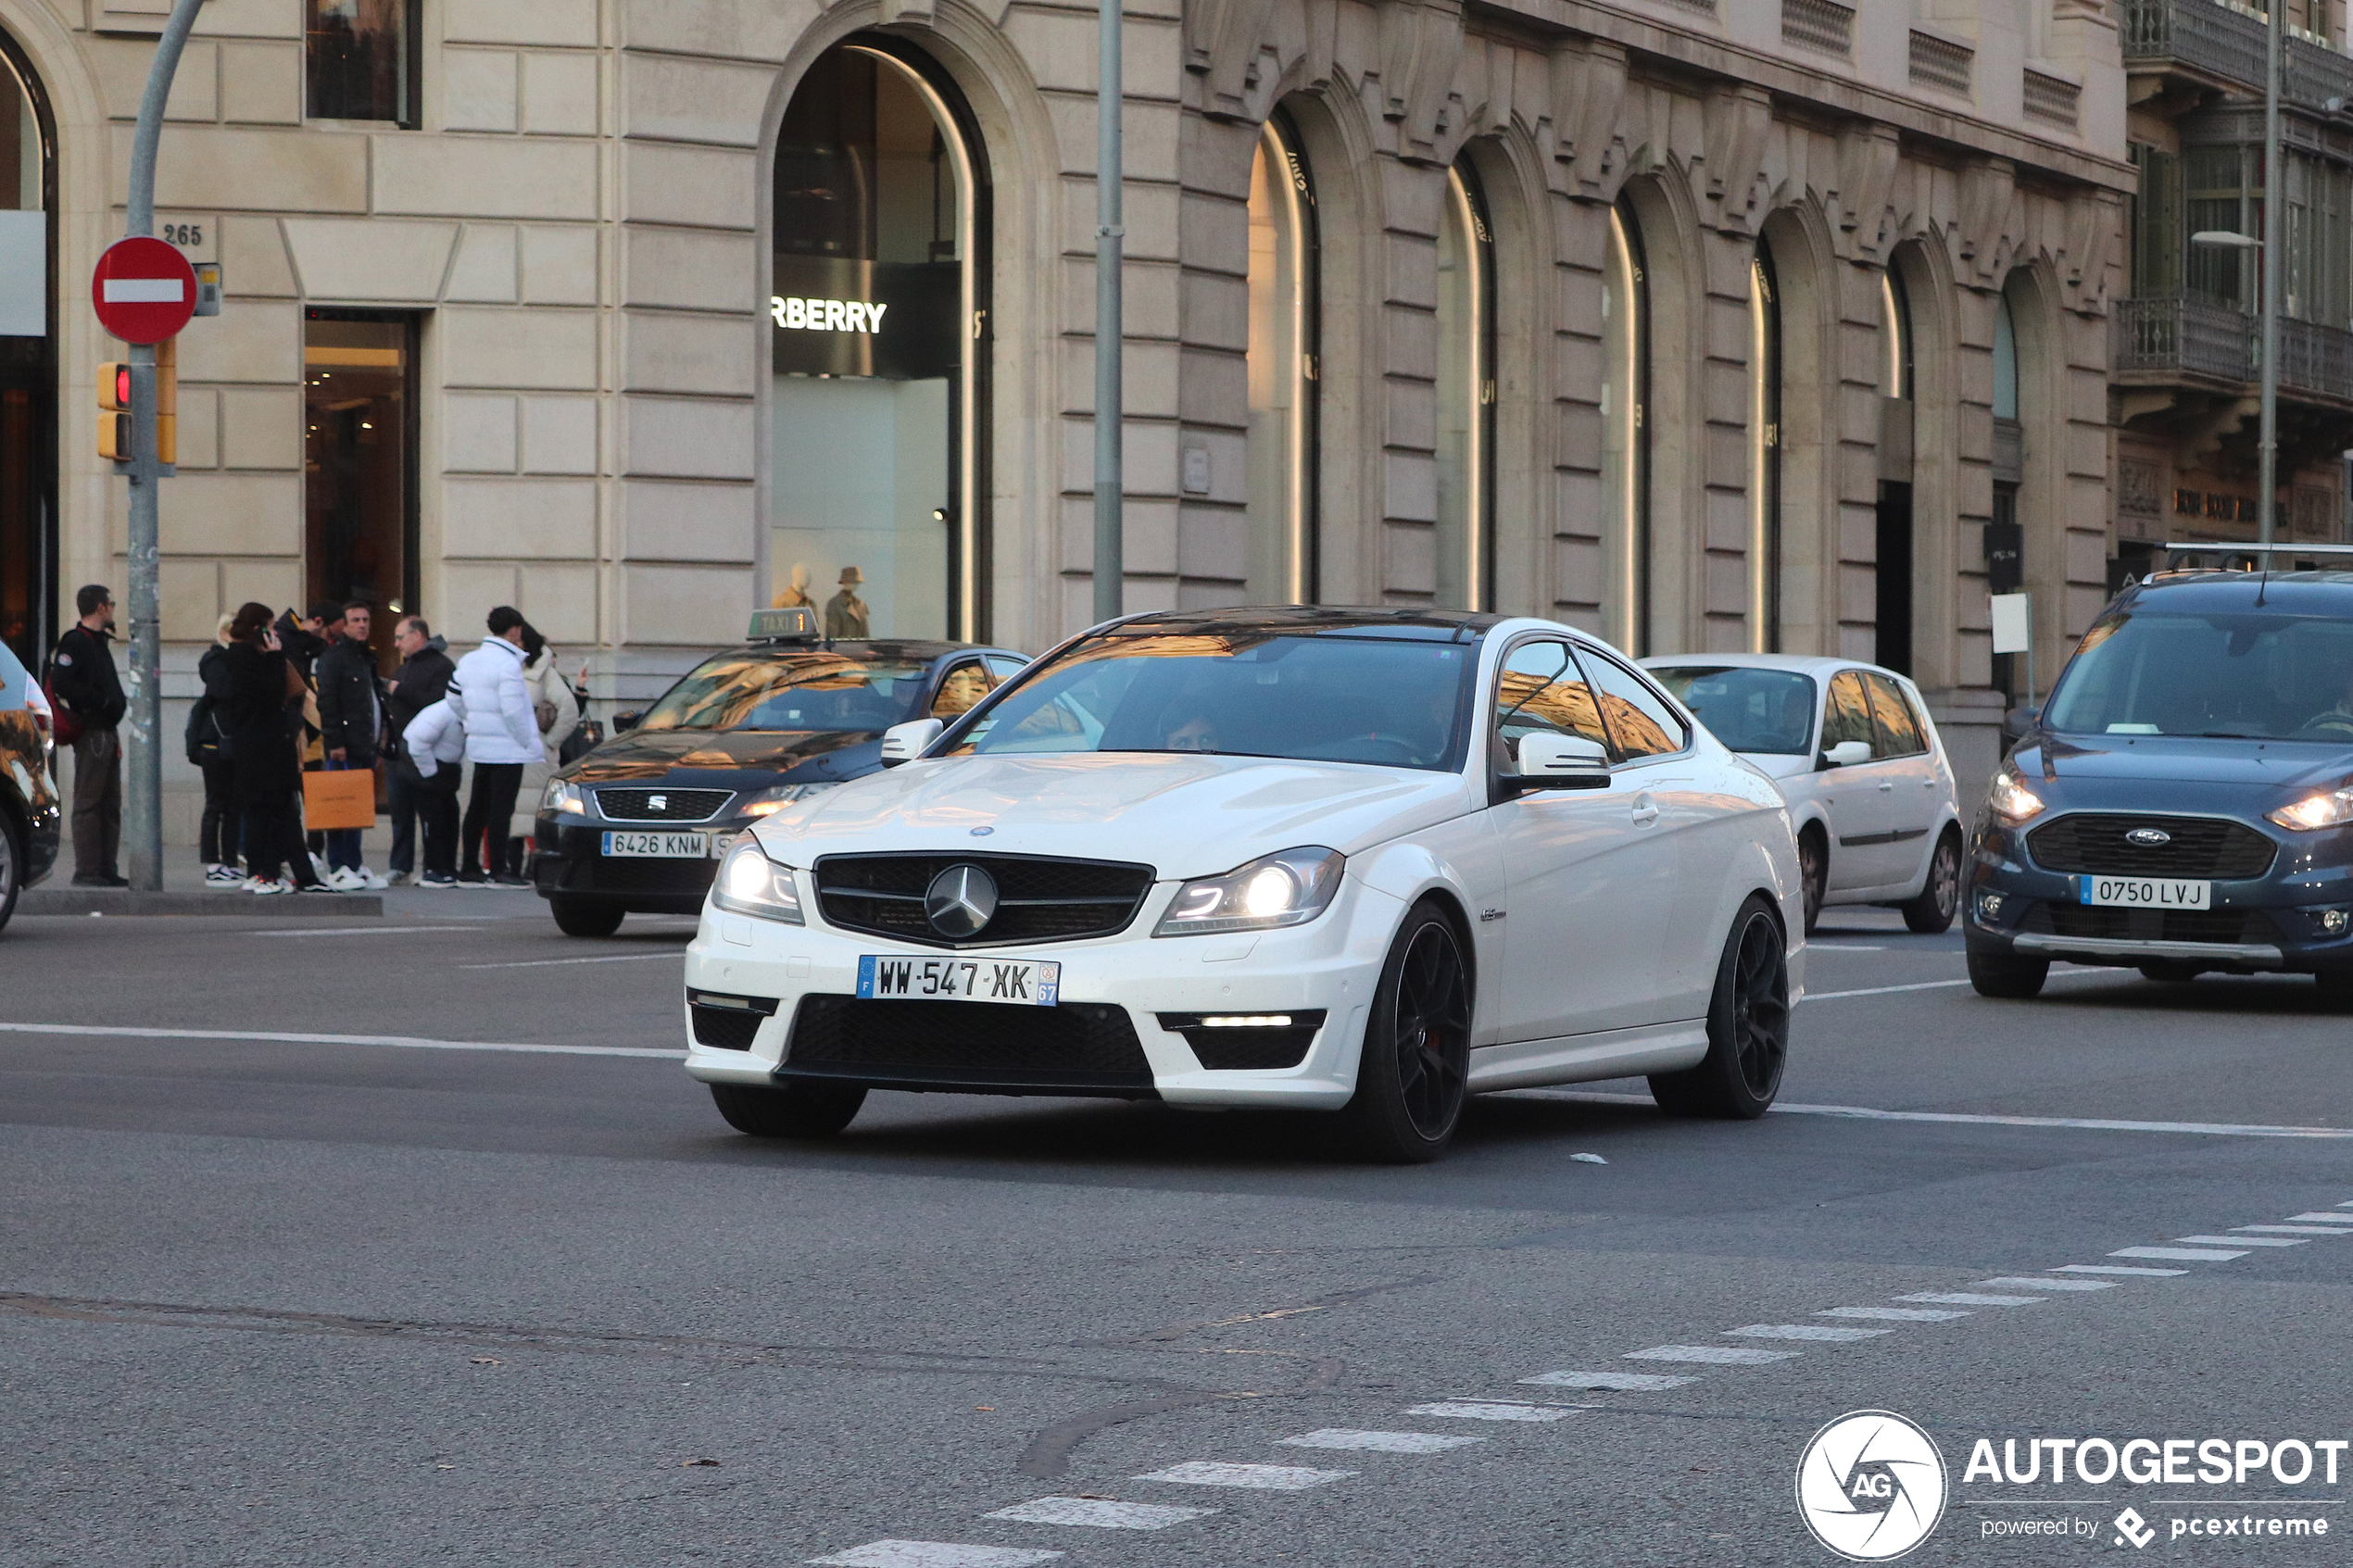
(1250, 110, 1317, 604)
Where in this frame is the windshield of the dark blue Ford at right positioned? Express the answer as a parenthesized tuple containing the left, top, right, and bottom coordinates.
(2043, 611, 2353, 746)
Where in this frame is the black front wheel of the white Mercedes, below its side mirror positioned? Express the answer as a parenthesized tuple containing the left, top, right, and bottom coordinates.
(1341, 900, 1471, 1163)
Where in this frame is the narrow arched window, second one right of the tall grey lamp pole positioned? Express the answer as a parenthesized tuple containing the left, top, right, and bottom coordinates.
(1435, 160, 1494, 608)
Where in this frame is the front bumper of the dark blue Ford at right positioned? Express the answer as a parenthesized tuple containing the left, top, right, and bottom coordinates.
(1962, 821, 2353, 973)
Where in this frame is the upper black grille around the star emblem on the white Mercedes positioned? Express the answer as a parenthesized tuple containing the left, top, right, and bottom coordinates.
(816, 856, 1153, 947)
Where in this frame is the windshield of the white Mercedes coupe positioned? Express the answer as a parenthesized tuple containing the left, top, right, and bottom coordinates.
(944, 633, 1476, 769)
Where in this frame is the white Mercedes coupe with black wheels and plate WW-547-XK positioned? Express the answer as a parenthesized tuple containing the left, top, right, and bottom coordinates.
(685, 608, 1803, 1159)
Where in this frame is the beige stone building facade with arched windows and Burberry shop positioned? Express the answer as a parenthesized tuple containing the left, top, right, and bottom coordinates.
(0, 0, 2136, 832)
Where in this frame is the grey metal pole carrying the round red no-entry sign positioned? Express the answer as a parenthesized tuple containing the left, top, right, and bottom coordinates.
(122, 0, 205, 894)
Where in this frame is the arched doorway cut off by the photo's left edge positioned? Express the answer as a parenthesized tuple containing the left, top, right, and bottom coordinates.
(0, 33, 57, 670)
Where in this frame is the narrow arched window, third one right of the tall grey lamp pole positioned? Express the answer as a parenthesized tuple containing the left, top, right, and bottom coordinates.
(1600, 202, 1652, 654)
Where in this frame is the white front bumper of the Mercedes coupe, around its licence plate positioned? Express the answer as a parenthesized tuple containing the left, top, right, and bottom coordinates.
(685, 872, 1404, 1110)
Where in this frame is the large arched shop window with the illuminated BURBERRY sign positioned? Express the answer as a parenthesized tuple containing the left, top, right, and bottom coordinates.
(767, 35, 988, 639)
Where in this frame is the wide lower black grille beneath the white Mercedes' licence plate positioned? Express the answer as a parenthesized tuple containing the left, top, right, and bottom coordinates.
(784, 995, 1153, 1096)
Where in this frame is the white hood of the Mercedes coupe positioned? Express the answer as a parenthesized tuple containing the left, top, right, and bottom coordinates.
(758, 752, 1468, 879)
